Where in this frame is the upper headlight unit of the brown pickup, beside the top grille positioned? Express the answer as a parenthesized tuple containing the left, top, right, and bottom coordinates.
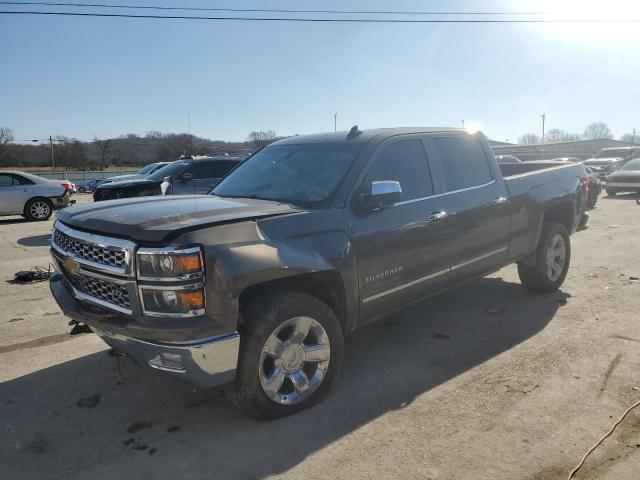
(138, 247, 204, 280)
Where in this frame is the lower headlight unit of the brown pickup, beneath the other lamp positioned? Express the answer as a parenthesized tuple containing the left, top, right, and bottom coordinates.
(140, 285, 204, 316)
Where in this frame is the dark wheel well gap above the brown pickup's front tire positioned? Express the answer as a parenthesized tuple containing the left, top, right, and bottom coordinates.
(239, 271, 347, 330)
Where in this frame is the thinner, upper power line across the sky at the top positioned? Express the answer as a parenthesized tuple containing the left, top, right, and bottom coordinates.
(0, 1, 551, 15)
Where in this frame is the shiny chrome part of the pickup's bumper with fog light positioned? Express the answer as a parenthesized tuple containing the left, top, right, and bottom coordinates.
(94, 330, 240, 388)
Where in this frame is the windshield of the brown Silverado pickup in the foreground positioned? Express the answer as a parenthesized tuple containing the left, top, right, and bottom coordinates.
(211, 143, 358, 207)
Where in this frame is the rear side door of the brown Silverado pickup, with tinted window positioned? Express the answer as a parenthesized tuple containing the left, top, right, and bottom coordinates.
(427, 132, 510, 277)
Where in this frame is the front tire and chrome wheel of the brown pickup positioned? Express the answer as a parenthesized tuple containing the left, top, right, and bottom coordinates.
(224, 292, 344, 420)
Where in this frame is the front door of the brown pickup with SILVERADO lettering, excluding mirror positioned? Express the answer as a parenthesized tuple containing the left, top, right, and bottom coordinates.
(352, 135, 450, 321)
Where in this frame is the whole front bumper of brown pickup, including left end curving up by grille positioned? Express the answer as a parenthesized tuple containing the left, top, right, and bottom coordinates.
(49, 272, 240, 388)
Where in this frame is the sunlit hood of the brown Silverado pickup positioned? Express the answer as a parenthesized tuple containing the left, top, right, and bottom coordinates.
(58, 195, 303, 244)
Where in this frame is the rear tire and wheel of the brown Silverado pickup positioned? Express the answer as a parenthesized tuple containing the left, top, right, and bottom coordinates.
(518, 223, 571, 293)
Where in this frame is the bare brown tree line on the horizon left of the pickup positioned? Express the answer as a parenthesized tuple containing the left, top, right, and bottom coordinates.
(0, 127, 279, 171)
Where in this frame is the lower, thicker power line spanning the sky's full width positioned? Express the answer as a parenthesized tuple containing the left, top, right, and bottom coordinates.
(0, 11, 640, 24)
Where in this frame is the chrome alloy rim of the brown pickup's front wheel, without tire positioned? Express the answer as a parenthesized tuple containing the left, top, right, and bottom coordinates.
(258, 317, 331, 405)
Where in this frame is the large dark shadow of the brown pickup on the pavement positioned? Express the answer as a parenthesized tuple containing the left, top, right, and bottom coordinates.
(0, 278, 568, 479)
